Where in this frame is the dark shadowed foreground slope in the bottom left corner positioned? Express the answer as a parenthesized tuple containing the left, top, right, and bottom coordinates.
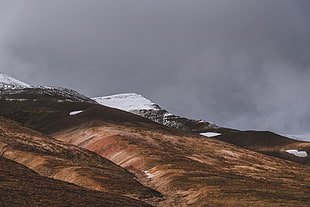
(0, 156, 148, 207)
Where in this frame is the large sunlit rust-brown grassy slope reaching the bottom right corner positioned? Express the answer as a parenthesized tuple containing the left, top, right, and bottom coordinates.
(53, 122, 310, 206)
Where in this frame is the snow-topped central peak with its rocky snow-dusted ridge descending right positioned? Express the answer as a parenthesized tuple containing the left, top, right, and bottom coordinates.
(93, 93, 235, 133)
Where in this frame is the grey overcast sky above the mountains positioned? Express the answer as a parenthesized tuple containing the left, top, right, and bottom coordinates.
(0, 0, 310, 134)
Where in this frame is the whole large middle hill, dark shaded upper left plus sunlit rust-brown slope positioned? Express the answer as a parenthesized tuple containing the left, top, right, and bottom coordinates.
(0, 99, 310, 207)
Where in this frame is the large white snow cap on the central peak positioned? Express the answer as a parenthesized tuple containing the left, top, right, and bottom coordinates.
(93, 93, 160, 112)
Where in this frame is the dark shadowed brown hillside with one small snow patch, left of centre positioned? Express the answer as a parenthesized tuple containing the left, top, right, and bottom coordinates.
(0, 94, 165, 133)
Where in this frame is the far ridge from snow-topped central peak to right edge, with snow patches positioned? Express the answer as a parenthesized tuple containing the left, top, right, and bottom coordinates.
(93, 93, 310, 165)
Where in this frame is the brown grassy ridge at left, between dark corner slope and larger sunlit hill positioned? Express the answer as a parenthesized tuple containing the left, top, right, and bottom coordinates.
(0, 117, 160, 202)
